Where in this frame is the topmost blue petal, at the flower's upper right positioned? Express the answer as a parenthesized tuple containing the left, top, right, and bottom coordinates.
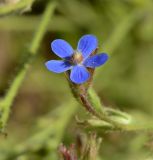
(77, 34, 98, 58)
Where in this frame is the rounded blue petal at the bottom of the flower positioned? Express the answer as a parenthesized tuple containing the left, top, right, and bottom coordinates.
(70, 65, 90, 84)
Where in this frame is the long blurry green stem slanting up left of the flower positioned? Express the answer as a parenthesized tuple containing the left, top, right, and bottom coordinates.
(0, 1, 56, 131)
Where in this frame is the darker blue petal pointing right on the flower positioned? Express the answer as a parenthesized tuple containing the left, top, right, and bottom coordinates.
(83, 53, 108, 68)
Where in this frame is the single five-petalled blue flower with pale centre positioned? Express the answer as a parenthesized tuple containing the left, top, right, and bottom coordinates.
(45, 35, 108, 84)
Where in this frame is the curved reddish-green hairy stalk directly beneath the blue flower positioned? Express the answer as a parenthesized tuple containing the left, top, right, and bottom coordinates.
(66, 72, 131, 130)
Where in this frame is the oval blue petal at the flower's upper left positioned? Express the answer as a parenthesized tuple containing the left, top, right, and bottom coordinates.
(51, 39, 74, 58)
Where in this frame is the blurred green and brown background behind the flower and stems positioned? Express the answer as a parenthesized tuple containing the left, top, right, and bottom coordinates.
(0, 0, 153, 160)
